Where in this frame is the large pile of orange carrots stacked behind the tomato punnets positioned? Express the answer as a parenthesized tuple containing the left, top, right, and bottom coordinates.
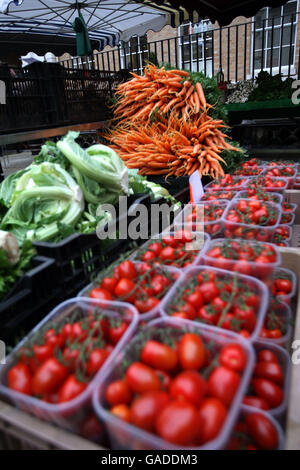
(105, 65, 239, 178)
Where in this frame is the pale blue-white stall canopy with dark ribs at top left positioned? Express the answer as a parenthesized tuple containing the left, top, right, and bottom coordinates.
(0, 0, 170, 50)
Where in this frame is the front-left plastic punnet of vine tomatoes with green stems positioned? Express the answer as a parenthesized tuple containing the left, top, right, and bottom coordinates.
(0, 298, 138, 433)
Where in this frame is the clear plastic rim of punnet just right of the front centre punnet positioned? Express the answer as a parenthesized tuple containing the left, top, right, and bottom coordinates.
(247, 339, 291, 418)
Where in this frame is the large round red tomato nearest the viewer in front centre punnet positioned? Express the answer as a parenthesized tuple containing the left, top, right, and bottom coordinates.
(156, 401, 200, 446)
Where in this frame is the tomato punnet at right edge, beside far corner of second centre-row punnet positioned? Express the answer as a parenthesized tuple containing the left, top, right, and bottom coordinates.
(267, 268, 297, 305)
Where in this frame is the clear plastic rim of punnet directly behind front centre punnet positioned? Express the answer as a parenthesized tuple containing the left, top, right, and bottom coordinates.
(160, 265, 269, 340)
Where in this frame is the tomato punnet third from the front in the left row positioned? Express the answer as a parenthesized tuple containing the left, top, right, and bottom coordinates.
(132, 228, 210, 270)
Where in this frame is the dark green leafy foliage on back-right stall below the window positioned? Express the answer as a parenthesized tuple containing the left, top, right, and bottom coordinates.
(248, 72, 293, 101)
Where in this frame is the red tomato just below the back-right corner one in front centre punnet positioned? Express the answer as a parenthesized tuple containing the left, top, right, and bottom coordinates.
(207, 366, 240, 406)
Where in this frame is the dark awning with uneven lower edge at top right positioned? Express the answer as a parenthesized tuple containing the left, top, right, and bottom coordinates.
(138, 0, 288, 26)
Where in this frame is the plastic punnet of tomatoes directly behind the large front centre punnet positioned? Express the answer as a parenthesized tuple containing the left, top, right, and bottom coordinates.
(161, 266, 269, 339)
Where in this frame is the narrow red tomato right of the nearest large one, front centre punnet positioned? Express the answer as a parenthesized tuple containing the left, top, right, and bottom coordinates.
(199, 398, 227, 444)
